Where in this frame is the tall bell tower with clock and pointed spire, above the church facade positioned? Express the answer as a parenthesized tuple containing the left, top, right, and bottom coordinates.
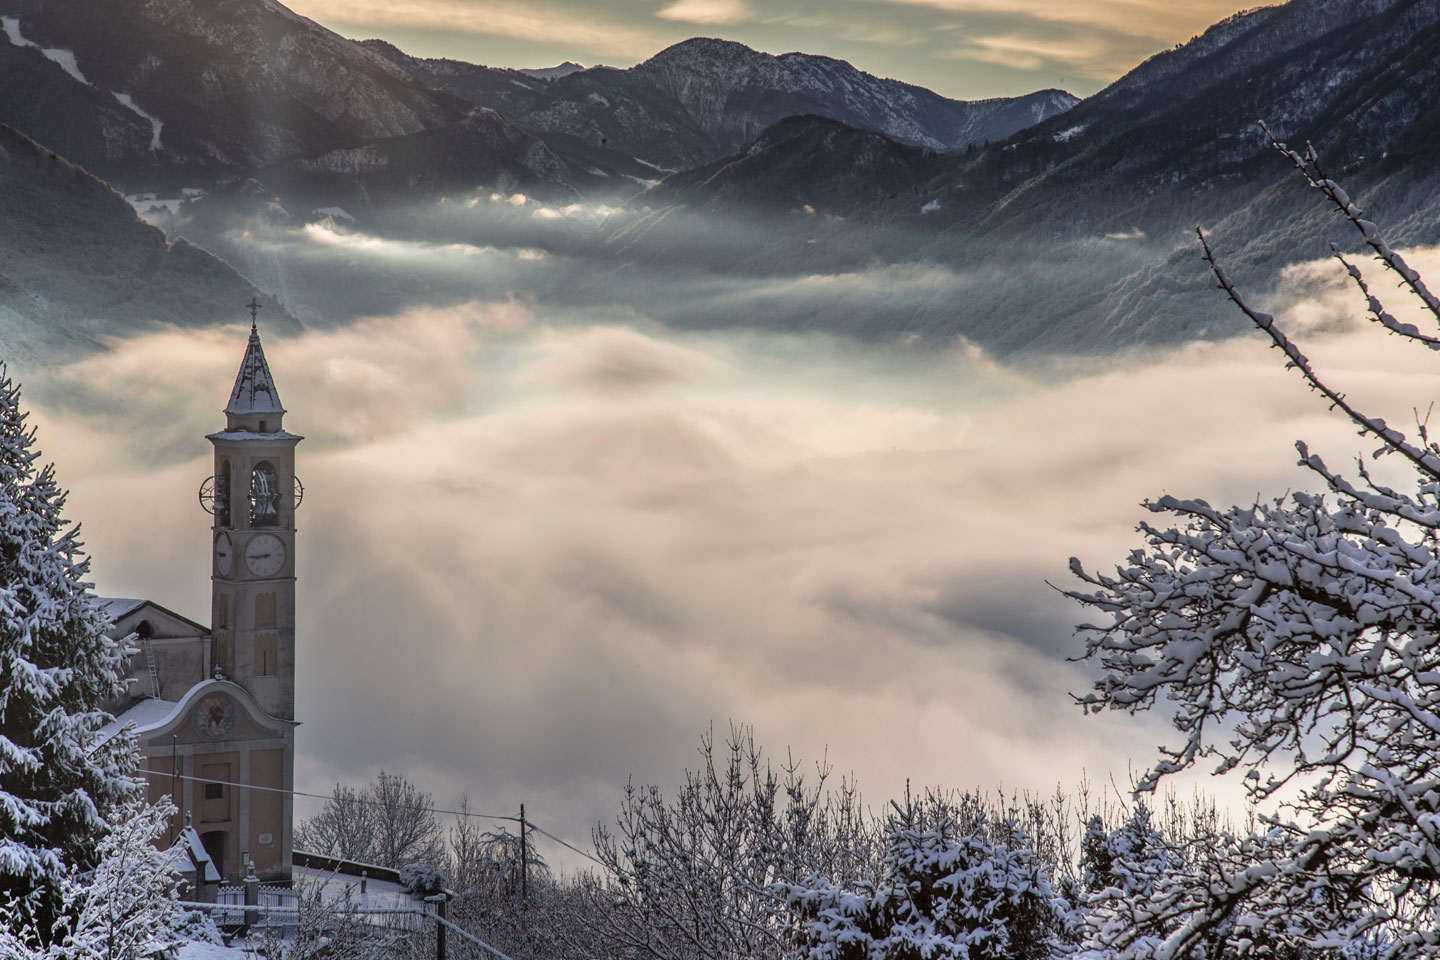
(200, 308, 304, 721)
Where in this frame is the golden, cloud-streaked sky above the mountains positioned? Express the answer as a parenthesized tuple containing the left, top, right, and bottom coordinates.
(288, 0, 1256, 99)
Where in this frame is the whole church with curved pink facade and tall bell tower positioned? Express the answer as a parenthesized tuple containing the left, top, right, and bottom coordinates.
(99, 316, 304, 882)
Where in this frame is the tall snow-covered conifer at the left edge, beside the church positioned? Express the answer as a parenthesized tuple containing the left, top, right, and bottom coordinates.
(0, 364, 137, 936)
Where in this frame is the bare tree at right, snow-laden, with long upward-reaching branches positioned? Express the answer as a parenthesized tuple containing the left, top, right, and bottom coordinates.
(1071, 131, 1440, 960)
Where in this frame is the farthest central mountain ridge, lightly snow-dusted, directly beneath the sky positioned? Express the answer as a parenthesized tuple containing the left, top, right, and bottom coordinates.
(361, 37, 1079, 170)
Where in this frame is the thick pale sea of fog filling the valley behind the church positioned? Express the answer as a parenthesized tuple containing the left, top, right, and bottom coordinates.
(10, 198, 1440, 862)
